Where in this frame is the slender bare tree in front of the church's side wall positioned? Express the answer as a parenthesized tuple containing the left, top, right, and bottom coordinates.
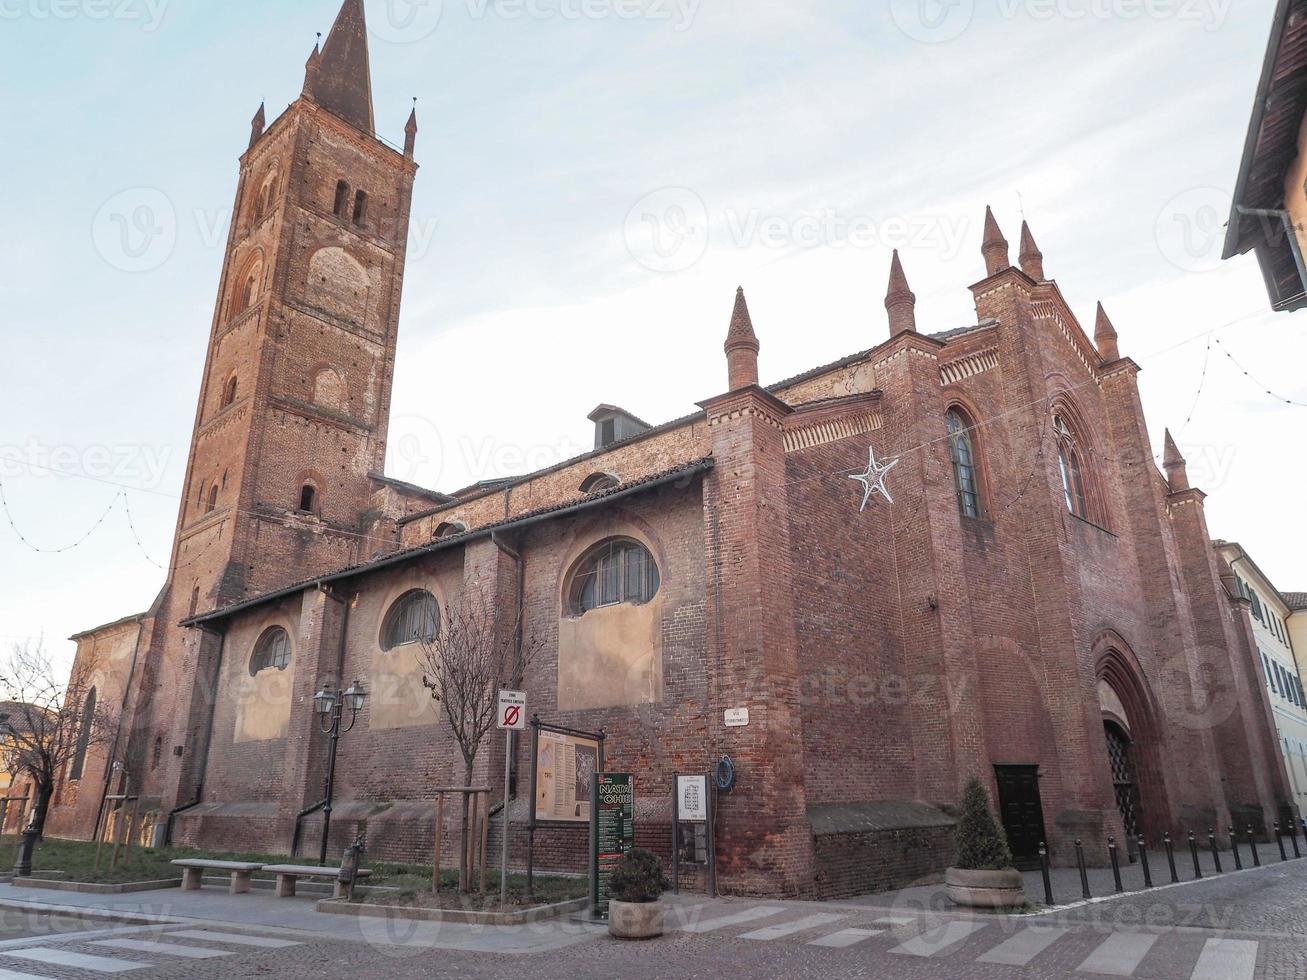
(418, 589, 540, 891)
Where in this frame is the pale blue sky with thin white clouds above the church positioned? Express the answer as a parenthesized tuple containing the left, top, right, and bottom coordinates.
(0, 0, 1307, 674)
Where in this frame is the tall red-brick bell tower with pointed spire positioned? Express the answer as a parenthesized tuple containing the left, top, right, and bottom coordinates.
(127, 0, 417, 815)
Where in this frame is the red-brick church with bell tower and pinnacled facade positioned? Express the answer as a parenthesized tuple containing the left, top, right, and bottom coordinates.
(50, 0, 1290, 898)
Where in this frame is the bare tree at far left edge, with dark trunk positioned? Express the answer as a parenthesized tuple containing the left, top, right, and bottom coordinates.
(0, 643, 115, 834)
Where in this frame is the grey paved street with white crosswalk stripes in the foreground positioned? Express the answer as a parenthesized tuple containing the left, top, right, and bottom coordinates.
(0, 861, 1307, 980)
